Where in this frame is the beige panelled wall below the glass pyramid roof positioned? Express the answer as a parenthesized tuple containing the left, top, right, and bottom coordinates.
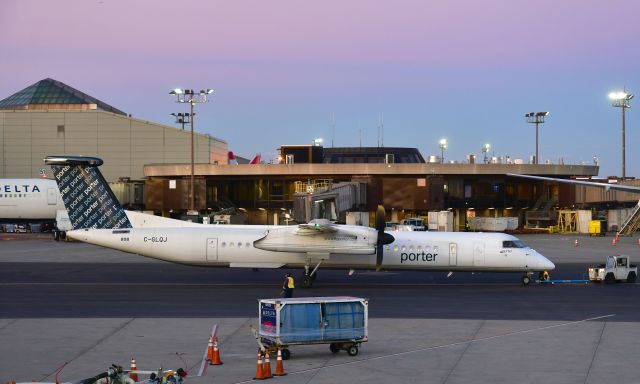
(0, 110, 228, 182)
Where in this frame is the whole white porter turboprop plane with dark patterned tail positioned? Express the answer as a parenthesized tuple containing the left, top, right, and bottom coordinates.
(45, 156, 555, 287)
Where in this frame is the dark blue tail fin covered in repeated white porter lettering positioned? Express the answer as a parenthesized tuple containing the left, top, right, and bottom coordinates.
(44, 156, 132, 229)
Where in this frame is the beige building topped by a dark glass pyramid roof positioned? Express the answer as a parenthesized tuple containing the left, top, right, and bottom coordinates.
(0, 78, 228, 207)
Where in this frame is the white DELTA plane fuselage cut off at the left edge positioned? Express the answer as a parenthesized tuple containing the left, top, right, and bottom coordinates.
(0, 179, 65, 222)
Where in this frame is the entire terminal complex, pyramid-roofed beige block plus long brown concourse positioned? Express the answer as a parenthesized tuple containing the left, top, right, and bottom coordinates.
(6, 79, 638, 230)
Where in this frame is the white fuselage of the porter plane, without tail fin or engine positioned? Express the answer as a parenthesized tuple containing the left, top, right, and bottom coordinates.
(67, 219, 554, 272)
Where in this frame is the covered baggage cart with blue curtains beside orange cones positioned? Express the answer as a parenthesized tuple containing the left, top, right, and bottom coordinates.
(256, 296, 369, 360)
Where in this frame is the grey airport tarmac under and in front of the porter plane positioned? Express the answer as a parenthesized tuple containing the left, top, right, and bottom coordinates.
(0, 234, 640, 384)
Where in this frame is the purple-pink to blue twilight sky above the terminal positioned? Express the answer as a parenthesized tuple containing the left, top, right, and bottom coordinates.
(0, 0, 640, 176)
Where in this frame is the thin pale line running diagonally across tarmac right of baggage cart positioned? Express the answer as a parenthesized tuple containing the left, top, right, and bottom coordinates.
(235, 314, 615, 384)
